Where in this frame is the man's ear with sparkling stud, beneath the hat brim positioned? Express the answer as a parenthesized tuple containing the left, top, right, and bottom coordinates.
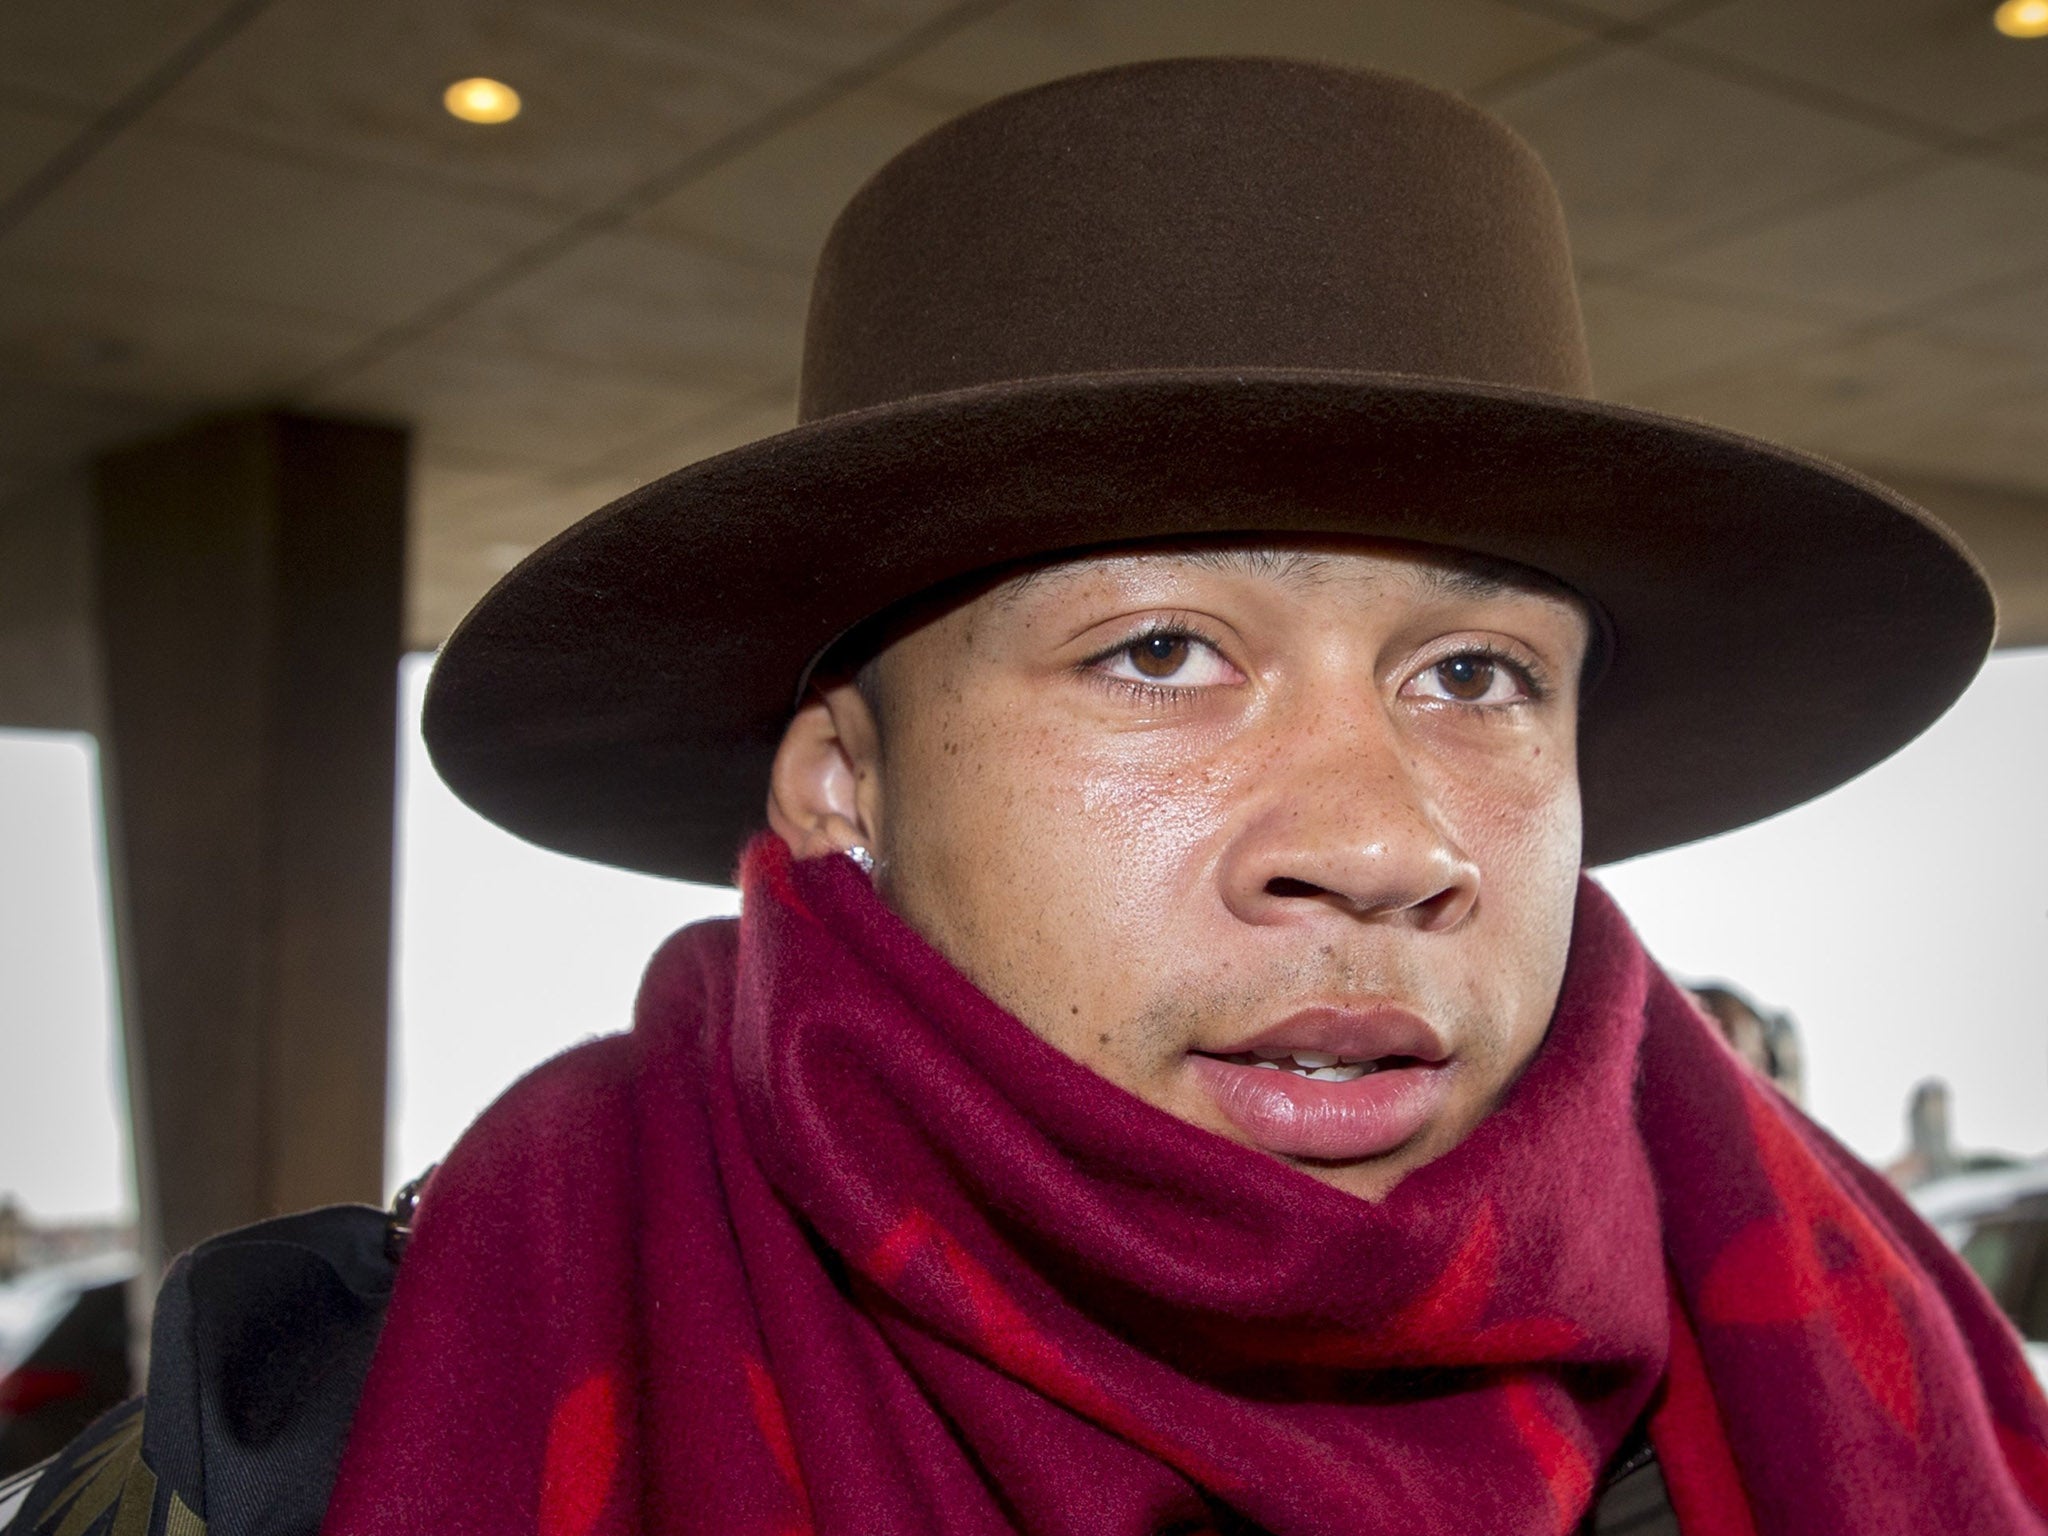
(768, 682, 883, 858)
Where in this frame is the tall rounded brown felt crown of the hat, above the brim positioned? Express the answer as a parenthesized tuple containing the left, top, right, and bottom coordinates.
(799, 59, 1589, 420)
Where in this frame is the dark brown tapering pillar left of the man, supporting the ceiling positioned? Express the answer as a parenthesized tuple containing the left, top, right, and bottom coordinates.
(94, 414, 406, 1257)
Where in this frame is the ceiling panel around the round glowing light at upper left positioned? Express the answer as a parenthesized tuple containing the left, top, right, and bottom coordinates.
(158, 0, 817, 211)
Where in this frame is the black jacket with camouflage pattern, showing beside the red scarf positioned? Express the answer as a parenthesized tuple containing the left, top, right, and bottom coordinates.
(0, 1206, 1677, 1536)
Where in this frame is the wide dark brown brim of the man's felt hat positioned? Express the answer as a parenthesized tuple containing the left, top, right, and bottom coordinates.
(426, 369, 1995, 881)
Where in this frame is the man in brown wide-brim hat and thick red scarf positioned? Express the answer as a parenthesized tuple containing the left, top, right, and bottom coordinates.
(4, 59, 2048, 1536)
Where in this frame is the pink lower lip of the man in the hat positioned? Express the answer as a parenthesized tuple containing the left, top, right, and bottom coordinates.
(1190, 1057, 1450, 1163)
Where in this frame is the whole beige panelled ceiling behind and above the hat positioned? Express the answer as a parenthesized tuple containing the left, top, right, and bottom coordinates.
(0, 0, 2048, 643)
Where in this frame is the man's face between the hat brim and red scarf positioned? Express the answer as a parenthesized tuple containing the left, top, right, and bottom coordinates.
(776, 543, 1587, 1198)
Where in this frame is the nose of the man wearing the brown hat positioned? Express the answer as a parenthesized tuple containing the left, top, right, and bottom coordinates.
(1219, 700, 1479, 932)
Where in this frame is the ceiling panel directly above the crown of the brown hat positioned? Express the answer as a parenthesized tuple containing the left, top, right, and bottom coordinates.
(893, 0, 1587, 104)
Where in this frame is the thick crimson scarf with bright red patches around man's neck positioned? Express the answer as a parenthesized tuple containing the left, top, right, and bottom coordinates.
(326, 840, 2048, 1536)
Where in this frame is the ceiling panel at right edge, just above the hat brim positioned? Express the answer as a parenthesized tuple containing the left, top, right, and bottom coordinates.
(1638, 330, 2048, 459)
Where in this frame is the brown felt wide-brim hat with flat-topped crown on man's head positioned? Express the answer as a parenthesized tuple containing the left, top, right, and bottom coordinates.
(426, 59, 1993, 881)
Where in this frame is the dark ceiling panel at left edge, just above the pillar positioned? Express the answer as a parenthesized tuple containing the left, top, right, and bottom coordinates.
(0, 260, 367, 403)
